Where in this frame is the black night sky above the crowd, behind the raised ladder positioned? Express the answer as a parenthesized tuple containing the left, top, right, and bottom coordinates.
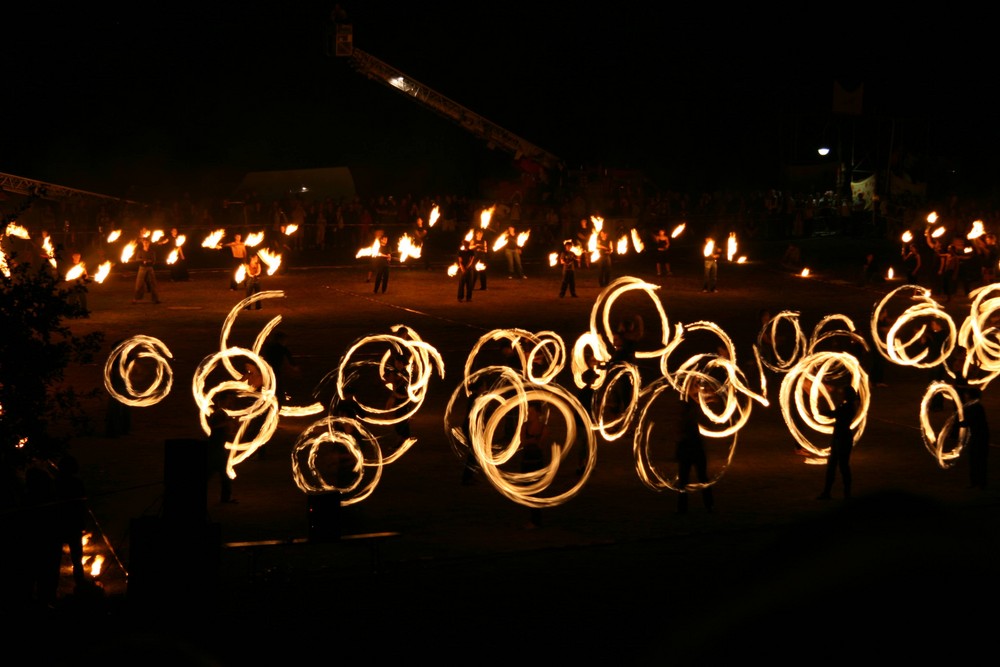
(0, 0, 1000, 200)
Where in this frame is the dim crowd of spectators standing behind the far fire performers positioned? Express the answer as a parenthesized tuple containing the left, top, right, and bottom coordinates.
(7, 176, 1000, 276)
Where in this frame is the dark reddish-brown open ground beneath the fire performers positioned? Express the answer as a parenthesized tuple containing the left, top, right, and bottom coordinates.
(9, 238, 1000, 665)
